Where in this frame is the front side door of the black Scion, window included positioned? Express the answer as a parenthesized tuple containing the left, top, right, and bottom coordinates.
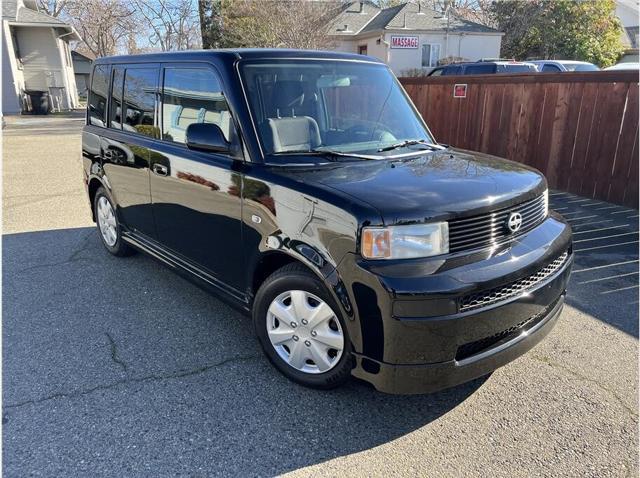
(150, 64, 246, 292)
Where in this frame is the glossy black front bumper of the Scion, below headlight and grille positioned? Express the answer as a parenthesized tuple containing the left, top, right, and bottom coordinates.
(341, 216, 573, 393)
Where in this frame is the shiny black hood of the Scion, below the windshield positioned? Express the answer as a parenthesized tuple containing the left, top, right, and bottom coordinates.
(284, 149, 547, 225)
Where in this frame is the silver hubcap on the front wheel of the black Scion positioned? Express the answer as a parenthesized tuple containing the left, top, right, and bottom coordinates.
(267, 290, 344, 373)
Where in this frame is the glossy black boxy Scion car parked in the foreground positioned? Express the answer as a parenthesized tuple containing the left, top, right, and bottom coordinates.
(83, 50, 573, 393)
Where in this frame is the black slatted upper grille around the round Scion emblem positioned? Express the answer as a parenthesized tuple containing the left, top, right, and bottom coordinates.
(449, 195, 547, 252)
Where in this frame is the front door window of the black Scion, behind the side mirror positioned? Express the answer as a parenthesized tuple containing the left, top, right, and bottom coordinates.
(162, 67, 232, 143)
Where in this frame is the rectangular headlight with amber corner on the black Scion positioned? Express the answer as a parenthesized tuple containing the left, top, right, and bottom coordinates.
(361, 222, 449, 259)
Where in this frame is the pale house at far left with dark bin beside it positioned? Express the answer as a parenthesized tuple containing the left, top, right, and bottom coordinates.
(2, 0, 80, 115)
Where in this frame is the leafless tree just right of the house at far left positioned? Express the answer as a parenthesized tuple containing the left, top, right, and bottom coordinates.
(65, 0, 136, 57)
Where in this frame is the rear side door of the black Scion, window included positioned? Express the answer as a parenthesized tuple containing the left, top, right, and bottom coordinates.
(100, 64, 159, 238)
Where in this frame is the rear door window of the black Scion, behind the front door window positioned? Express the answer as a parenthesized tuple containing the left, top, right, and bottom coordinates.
(122, 68, 160, 138)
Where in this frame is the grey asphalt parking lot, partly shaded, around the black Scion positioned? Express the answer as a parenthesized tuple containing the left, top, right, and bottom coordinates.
(2, 117, 638, 477)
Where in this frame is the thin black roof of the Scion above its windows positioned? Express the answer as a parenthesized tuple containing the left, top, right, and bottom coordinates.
(95, 48, 384, 64)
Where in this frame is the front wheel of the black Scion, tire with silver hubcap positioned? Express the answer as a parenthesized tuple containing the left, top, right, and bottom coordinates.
(253, 264, 354, 390)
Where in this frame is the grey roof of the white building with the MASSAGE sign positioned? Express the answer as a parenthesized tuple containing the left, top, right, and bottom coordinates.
(329, 1, 500, 36)
